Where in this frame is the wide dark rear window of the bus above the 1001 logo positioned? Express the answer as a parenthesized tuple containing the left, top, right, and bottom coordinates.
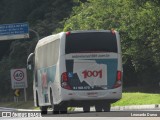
(65, 32, 117, 54)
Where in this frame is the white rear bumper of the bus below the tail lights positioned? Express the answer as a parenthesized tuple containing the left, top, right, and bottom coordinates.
(60, 87, 122, 106)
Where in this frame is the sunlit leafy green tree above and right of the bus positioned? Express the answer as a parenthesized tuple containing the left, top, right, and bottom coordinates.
(64, 0, 160, 86)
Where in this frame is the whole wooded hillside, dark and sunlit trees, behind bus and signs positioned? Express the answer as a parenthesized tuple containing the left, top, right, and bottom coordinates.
(0, 0, 160, 101)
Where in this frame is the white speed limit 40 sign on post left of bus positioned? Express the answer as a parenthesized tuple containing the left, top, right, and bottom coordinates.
(11, 68, 28, 102)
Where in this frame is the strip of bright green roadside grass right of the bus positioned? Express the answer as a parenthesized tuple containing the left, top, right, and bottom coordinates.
(112, 92, 160, 106)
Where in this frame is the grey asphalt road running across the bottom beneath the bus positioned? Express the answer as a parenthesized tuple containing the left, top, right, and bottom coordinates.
(0, 108, 160, 120)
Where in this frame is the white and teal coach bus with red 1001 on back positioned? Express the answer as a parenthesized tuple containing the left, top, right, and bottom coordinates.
(27, 30, 122, 114)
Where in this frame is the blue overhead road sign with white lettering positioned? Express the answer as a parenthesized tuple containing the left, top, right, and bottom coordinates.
(0, 23, 29, 40)
